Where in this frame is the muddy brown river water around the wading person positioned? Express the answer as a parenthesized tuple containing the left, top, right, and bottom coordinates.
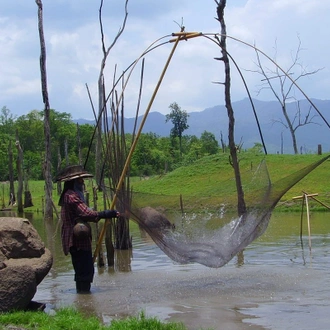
(7, 212, 330, 330)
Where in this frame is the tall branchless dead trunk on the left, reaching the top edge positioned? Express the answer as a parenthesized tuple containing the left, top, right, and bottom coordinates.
(35, 0, 54, 219)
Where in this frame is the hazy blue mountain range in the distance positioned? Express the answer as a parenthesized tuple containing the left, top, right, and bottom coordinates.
(74, 98, 330, 153)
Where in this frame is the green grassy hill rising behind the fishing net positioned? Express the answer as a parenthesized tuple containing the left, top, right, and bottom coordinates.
(132, 152, 330, 211)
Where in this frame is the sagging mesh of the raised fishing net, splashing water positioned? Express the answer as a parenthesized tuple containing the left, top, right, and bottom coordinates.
(123, 156, 329, 267)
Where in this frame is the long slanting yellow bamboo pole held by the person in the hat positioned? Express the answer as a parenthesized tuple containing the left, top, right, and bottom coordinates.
(93, 34, 191, 262)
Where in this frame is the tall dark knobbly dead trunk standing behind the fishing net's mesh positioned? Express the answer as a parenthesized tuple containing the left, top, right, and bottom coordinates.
(215, 0, 246, 215)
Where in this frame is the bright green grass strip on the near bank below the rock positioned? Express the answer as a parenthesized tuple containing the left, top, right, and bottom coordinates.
(0, 307, 192, 330)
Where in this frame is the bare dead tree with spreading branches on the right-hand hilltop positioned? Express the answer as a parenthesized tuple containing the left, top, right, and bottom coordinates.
(249, 37, 321, 154)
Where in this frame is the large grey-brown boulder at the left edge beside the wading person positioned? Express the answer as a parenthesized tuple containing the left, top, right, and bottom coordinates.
(0, 217, 53, 312)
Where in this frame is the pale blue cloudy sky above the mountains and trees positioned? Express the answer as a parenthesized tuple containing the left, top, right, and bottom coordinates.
(0, 0, 330, 119)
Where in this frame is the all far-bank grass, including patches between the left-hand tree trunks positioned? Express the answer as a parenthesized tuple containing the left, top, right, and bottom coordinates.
(2, 152, 330, 212)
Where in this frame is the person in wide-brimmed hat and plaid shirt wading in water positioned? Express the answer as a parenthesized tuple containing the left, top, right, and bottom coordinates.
(56, 165, 119, 293)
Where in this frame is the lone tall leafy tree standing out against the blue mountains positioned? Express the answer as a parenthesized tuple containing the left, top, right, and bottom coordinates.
(166, 102, 189, 157)
